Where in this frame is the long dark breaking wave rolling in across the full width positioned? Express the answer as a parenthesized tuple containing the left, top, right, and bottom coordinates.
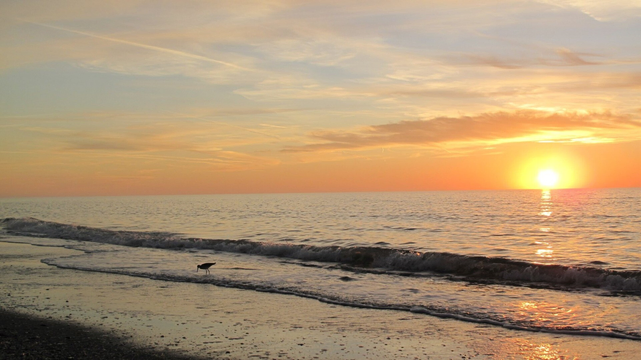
(1, 218, 641, 295)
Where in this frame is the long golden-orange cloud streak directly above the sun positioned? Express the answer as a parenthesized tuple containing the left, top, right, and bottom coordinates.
(283, 110, 641, 153)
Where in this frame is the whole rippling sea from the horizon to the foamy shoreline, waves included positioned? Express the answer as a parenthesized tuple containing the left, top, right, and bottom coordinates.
(0, 188, 641, 340)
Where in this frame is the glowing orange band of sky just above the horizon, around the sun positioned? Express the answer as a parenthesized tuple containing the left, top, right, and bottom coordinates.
(3, 141, 641, 196)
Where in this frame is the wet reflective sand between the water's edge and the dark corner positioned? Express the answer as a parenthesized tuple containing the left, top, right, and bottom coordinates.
(0, 239, 641, 359)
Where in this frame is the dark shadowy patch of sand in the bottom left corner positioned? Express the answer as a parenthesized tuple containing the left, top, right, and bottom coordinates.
(0, 308, 199, 360)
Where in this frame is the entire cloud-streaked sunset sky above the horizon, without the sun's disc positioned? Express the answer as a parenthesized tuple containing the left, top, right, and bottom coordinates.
(0, 0, 641, 197)
